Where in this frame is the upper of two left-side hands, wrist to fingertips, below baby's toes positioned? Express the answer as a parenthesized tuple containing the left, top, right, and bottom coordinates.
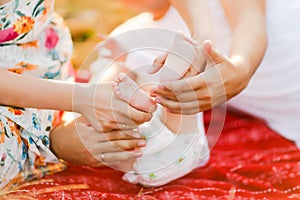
(73, 83, 152, 132)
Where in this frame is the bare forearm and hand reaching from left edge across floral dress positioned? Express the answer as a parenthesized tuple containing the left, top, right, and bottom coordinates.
(0, 70, 151, 131)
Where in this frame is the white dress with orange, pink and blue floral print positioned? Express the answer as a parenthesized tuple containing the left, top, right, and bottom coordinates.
(0, 0, 72, 188)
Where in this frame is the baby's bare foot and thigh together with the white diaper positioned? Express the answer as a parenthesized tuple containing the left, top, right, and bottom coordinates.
(115, 73, 209, 187)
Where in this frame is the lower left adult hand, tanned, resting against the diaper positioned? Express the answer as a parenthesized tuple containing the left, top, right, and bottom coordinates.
(50, 116, 146, 170)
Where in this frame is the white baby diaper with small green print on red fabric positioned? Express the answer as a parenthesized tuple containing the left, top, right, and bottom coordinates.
(123, 108, 209, 187)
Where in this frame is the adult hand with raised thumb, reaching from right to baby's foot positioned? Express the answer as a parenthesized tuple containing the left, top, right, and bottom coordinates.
(151, 41, 251, 114)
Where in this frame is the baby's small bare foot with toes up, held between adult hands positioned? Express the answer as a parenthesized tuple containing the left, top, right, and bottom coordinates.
(114, 73, 157, 113)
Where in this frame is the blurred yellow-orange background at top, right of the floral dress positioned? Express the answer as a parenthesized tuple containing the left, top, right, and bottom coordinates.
(56, 0, 137, 68)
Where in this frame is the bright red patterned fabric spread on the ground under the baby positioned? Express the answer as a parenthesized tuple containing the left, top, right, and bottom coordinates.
(0, 108, 300, 200)
